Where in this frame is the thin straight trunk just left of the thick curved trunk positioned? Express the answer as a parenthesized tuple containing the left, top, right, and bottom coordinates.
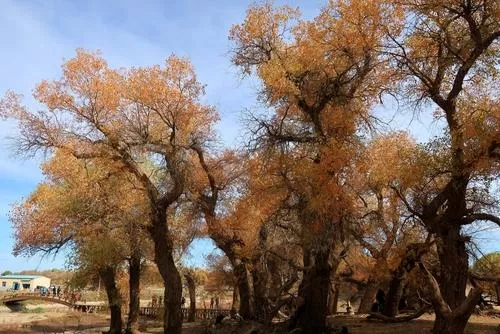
(127, 248, 141, 333)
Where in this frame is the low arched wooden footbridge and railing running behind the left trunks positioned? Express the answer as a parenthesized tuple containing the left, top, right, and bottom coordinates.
(0, 292, 230, 319)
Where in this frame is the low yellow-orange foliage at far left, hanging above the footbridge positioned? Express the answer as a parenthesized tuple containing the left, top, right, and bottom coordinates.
(10, 150, 147, 253)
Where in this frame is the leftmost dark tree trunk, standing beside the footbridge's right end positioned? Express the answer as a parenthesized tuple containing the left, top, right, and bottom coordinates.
(99, 266, 123, 334)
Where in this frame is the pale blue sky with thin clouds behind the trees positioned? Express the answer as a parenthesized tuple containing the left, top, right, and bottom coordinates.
(0, 0, 500, 271)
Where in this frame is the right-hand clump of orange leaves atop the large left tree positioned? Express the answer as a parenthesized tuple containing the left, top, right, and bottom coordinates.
(124, 56, 218, 145)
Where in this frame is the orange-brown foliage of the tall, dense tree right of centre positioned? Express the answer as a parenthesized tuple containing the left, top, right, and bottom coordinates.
(230, 0, 394, 235)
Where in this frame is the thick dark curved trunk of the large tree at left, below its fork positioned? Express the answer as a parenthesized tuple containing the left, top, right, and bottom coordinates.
(149, 208, 182, 334)
